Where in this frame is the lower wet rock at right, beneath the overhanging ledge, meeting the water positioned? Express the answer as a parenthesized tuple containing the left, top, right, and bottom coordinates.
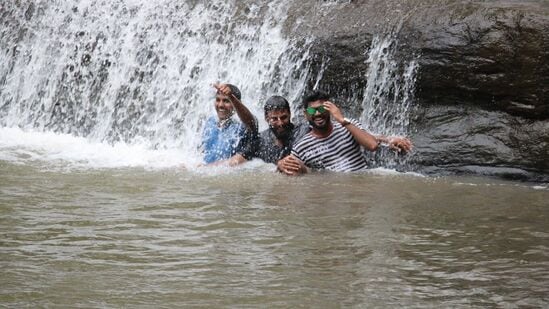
(413, 106, 549, 181)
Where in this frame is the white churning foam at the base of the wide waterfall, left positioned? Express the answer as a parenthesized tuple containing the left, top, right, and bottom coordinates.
(0, 127, 200, 169)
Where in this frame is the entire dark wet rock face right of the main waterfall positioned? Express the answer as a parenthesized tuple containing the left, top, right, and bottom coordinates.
(288, 1, 549, 181)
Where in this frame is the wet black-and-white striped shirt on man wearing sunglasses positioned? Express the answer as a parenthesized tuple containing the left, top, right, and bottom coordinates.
(292, 119, 368, 172)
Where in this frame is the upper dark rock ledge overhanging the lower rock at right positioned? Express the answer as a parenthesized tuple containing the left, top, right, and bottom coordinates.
(407, 3, 549, 119)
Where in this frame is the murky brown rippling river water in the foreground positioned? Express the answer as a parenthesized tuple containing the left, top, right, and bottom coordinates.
(0, 161, 549, 308)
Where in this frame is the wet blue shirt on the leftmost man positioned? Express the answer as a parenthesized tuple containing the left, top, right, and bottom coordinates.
(202, 117, 250, 163)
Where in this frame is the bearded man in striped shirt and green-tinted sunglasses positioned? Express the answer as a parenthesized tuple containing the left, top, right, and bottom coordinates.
(281, 92, 412, 175)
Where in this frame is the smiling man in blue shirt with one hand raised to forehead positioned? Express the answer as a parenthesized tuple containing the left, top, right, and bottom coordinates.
(202, 84, 257, 166)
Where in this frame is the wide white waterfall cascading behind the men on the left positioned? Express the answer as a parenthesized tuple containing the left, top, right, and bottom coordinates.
(0, 0, 308, 160)
